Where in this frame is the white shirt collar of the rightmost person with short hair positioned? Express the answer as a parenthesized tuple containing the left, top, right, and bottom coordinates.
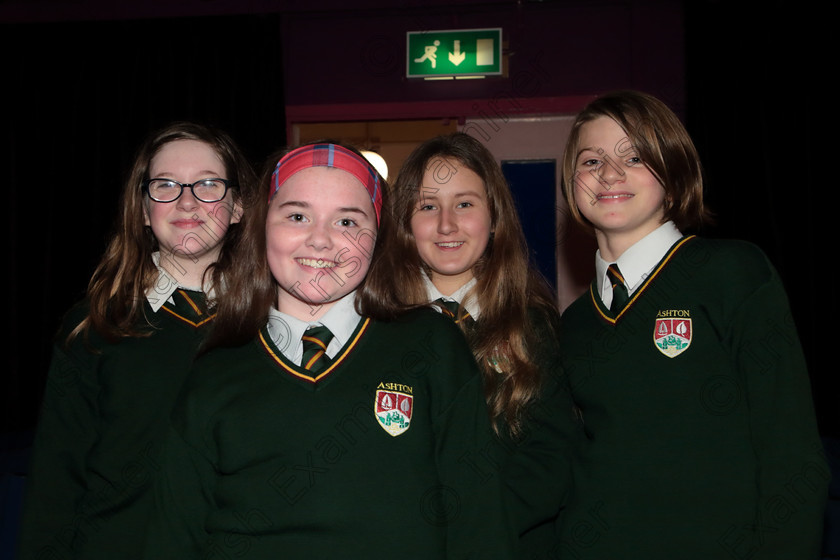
(595, 221, 683, 307)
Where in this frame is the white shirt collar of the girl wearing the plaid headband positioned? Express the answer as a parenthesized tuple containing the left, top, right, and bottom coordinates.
(268, 290, 362, 365)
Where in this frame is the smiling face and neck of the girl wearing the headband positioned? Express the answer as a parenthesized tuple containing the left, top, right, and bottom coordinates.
(265, 167, 376, 321)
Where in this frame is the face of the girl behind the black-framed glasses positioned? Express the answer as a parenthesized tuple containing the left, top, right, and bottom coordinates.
(144, 140, 241, 285)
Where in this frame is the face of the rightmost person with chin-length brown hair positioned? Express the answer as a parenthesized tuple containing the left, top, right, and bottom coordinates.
(574, 117, 665, 261)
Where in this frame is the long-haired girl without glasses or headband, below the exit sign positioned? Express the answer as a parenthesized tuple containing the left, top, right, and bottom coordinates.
(384, 132, 580, 558)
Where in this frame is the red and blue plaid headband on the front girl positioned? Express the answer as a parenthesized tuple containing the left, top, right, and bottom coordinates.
(268, 144, 382, 225)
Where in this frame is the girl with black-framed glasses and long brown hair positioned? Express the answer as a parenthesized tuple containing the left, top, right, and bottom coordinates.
(20, 122, 256, 559)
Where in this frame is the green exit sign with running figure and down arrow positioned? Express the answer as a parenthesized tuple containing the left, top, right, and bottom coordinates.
(406, 27, 502, 78)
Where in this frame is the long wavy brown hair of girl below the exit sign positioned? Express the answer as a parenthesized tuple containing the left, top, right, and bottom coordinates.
(376, 132, 556, 435)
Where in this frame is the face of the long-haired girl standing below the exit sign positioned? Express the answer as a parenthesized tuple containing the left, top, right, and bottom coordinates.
(411, 159, 492, 295)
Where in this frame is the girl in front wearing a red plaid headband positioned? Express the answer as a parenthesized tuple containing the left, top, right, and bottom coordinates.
(141, 142, 512, 560)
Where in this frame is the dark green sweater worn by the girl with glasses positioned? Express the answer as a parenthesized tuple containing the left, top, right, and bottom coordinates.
(19, 291, 212, 560)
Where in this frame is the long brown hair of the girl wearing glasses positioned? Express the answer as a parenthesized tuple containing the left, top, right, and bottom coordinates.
(68, 122, 255, 341)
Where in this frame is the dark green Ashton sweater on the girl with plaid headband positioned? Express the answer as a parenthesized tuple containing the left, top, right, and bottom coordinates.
(141, 310, 512, 560)
